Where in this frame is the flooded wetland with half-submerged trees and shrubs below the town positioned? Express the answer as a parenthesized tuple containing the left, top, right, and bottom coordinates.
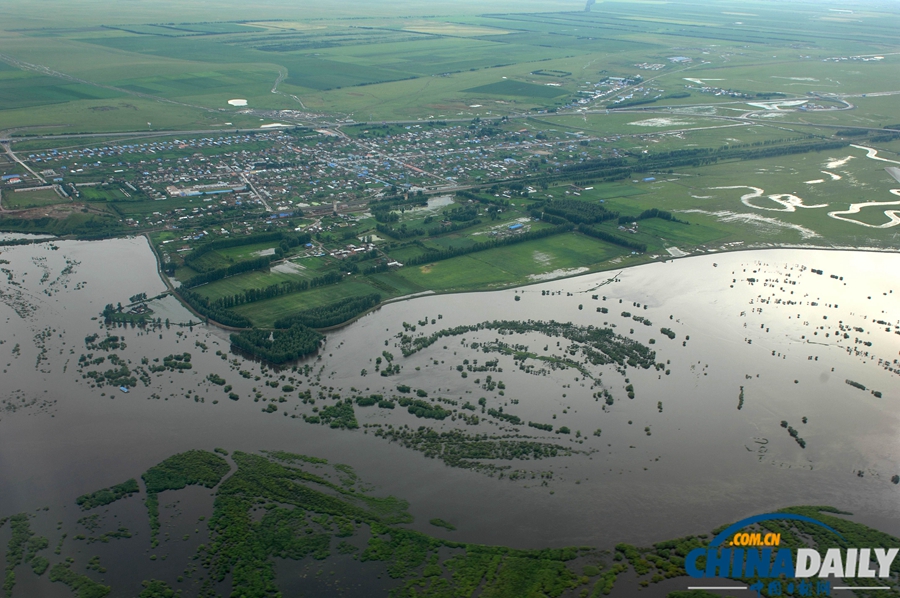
(0, 237, 900, 596)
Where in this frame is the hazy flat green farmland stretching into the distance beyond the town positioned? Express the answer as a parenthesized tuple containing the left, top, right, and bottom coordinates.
(0, 2, 900, 130)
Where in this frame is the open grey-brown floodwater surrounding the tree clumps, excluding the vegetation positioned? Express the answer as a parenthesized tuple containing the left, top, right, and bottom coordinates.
(0, 238, 900, 595)
